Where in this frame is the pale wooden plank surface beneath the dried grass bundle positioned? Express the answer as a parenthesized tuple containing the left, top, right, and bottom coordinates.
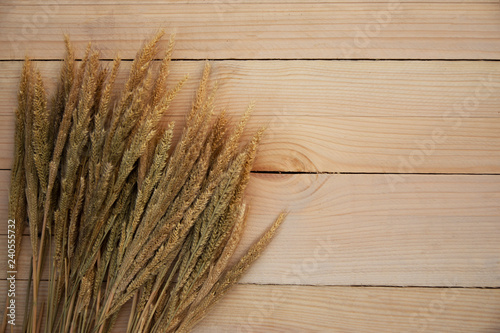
(0, 0, 500, 332)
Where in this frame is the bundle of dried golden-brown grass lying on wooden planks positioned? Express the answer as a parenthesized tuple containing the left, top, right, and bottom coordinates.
(4, 32, 284, 332)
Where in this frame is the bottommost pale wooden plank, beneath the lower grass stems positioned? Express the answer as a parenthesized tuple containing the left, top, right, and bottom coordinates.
(0, 280, 500, 333)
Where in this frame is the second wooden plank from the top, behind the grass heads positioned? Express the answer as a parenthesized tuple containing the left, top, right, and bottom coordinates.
(0, 61, 500, 173)
